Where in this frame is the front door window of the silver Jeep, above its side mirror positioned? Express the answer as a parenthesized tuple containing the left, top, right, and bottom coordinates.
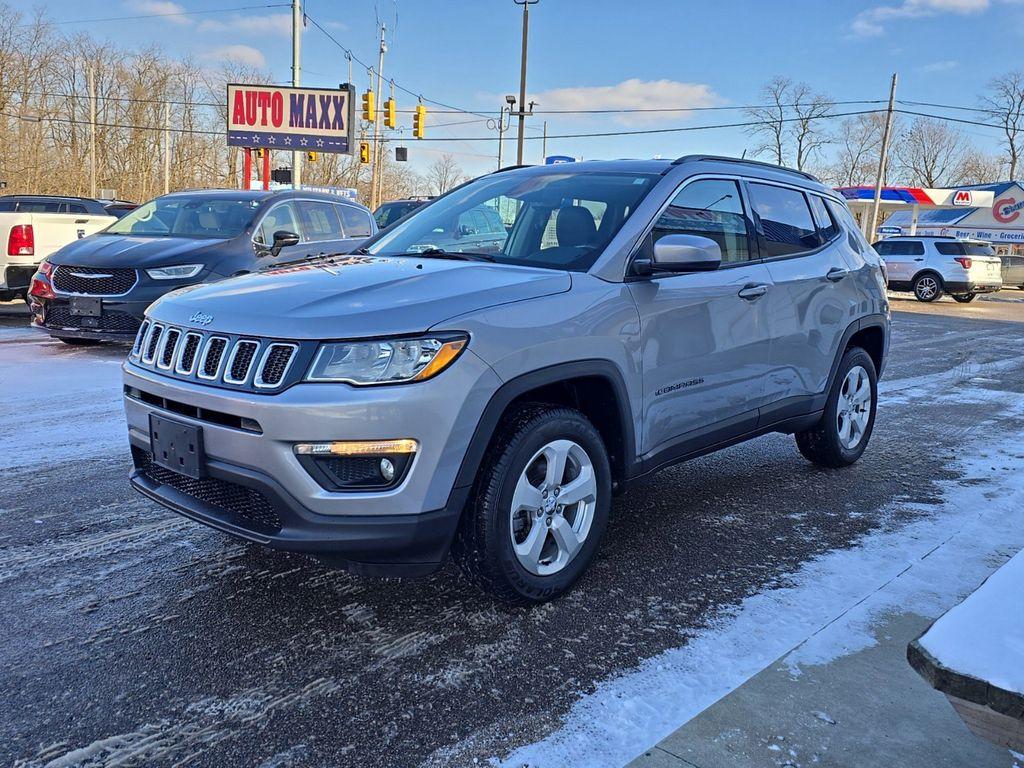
(652, 179, 751, 263)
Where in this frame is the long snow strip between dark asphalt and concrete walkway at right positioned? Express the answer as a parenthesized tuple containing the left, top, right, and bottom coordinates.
(501, 387, 1024, 768)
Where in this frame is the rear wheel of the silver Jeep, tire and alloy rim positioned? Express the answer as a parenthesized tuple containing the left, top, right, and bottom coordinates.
(796, 347, 879, 468)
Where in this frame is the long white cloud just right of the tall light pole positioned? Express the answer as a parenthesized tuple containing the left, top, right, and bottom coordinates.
(527, 78, 723, 124)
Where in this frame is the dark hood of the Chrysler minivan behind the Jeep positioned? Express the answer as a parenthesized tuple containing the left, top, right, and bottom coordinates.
(47, 234, 226, 267)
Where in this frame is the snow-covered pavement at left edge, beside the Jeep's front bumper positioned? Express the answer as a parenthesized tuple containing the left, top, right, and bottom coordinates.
(0, 328, 128, 469)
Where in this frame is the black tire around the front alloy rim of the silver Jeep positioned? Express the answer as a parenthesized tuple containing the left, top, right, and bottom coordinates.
(483, 410, 611, 602)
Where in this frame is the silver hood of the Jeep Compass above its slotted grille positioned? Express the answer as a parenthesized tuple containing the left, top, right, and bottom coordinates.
(150, 256, 571, 339)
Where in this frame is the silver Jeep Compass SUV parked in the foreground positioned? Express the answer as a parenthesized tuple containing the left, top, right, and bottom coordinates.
(124, 156, 889, 602)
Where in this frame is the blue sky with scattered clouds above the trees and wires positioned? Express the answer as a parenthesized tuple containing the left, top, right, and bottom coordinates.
(19, 0, 1024, 172)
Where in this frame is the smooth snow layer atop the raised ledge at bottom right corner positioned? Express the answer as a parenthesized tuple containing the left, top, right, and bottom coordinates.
(921, 552, 1024, 693)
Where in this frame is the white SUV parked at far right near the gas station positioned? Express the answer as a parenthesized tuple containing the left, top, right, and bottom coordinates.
(873, 236, 1002, 304)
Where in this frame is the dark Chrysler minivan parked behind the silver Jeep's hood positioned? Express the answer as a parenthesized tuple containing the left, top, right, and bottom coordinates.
(30, 189, 377, 344)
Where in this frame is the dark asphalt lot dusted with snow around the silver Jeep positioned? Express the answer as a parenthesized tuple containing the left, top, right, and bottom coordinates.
(0, 291, 1024, 766)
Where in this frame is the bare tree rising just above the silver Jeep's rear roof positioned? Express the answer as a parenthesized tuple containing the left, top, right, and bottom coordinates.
(746, 77, 833, 170)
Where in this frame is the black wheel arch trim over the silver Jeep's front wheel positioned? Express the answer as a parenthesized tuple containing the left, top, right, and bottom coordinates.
(450, 359, 636, 506)
